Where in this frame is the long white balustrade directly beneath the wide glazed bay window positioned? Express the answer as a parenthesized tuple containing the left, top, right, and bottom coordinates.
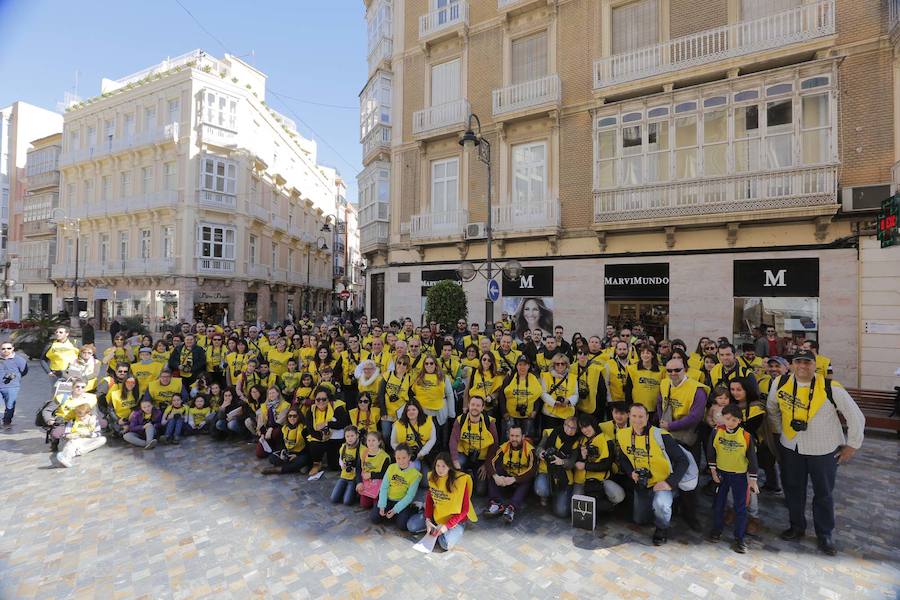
(594, 166, 837, 226)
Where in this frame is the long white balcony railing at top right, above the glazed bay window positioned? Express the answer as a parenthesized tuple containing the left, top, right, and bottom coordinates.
(594, 0, 835, 89)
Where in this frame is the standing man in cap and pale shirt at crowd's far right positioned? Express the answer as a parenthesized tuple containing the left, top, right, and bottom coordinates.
(766, 350, 866, 556)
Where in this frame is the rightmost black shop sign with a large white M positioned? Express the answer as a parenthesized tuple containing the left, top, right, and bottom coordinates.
(734, 258, 819, 298)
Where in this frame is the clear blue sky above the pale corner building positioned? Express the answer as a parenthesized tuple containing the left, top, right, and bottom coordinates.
(0, 0, 367, 202)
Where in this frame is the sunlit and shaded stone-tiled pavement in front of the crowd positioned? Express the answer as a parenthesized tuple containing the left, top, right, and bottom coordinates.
(0, 354, 900, 599)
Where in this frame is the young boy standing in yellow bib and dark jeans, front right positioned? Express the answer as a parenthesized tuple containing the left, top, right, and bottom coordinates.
(707, 403, 759, 554)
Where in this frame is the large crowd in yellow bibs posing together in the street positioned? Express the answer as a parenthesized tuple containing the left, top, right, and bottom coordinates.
(12, 316, 865, 555)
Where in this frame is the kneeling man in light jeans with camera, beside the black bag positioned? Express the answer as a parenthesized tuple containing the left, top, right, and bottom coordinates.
(616, 404, 690, 546)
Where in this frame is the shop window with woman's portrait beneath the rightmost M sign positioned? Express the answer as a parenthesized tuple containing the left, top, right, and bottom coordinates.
(734, 297, 819, 354)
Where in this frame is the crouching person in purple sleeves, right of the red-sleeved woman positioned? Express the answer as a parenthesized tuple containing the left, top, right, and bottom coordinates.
(485, 425, 537, 524)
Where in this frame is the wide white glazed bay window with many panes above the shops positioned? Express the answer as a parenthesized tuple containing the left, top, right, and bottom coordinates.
(594, 72, 837, 190)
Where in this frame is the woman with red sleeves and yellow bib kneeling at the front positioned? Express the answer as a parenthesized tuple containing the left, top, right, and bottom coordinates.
(407, 452, 478, 550)
